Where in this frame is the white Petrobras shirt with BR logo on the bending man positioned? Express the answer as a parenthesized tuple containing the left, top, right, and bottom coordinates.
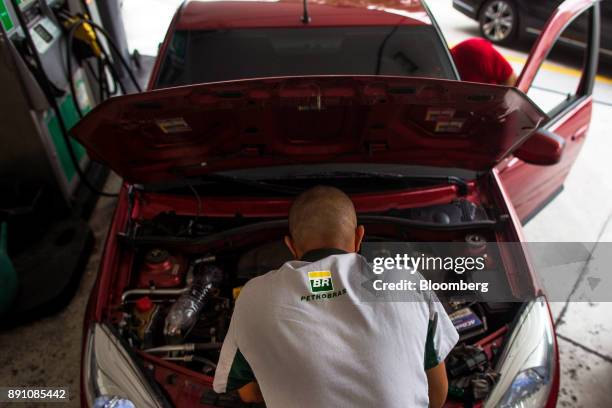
(214, 250, 459, 408)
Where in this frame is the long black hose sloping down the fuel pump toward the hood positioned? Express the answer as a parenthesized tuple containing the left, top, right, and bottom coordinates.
(11, 0, 118, 197)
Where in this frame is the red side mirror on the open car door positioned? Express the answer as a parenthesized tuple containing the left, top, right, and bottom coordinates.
(514, 129, 565, 166)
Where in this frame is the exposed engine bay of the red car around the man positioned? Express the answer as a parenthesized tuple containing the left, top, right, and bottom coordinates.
(112, 200, 520, 406)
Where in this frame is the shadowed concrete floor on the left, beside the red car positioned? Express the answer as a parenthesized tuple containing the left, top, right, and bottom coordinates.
(0, 174, 121, 408)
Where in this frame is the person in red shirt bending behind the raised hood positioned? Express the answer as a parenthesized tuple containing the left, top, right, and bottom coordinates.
(451, 38, 516, 86)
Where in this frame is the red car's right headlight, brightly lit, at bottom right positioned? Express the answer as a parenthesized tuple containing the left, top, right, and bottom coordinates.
(485, 297, 556, 408)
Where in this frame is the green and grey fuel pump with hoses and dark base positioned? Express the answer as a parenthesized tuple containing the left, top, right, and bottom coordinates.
(0, 0, 139, 322)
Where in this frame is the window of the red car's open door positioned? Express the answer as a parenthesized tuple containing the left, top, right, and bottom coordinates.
(527, 12, 590, 116)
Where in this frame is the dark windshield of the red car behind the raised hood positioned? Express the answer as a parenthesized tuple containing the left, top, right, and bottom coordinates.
(157, 26, 455, 88)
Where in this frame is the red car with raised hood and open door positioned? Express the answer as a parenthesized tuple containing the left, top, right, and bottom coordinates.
(73, 0, 599, 408)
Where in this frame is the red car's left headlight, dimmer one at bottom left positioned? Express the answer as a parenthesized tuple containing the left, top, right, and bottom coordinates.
(83, 323, 164, 408)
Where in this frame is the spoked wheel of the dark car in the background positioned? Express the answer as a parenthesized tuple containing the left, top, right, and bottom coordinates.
(478, 0, 518, 44)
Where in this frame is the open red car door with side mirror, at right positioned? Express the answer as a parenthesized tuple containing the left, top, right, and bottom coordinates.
(497, 0, 600, 223)
